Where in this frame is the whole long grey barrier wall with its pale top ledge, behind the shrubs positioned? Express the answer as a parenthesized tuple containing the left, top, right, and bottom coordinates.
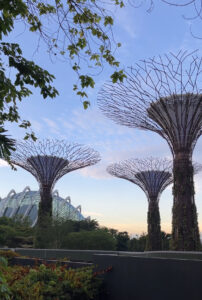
(1, 248, 202, 300)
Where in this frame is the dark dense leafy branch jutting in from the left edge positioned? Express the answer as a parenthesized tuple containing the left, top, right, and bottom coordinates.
(0, 41, 58, 160)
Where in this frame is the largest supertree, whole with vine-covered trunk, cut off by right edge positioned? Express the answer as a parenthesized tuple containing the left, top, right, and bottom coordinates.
(98, 51, 202, 250)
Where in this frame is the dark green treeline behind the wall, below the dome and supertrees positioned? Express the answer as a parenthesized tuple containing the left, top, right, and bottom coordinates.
(0, 217, 170, 252)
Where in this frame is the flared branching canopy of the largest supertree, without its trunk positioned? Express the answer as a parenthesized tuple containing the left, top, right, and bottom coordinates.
(98, 51, 202, 153)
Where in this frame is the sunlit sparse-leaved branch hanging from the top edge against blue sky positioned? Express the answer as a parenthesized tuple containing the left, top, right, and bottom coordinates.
(0, 0, 125, 104)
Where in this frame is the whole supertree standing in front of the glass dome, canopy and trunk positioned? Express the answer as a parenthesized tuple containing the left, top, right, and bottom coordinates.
(11, 139, 100, 246)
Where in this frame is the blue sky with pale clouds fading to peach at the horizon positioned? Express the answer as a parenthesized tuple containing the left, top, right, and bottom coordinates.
(0, 1, 202, 235)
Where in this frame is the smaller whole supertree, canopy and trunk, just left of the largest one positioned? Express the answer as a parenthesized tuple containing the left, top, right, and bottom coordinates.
(107, 157, 173, 251)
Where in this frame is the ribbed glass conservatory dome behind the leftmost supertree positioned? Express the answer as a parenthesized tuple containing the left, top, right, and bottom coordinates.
(0, 187, 85, 226)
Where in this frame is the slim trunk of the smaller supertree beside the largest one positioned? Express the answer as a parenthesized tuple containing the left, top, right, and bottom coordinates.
(145, 199, 162, 251)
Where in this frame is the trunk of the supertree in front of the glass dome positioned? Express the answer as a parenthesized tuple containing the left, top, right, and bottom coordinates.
(35, 186, 52, 248)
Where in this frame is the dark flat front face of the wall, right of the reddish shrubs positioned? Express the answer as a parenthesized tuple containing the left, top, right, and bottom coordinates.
(94, 255, 202, 300)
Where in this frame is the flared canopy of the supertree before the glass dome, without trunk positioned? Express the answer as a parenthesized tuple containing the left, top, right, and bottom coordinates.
(11, 139, 100, 184)
